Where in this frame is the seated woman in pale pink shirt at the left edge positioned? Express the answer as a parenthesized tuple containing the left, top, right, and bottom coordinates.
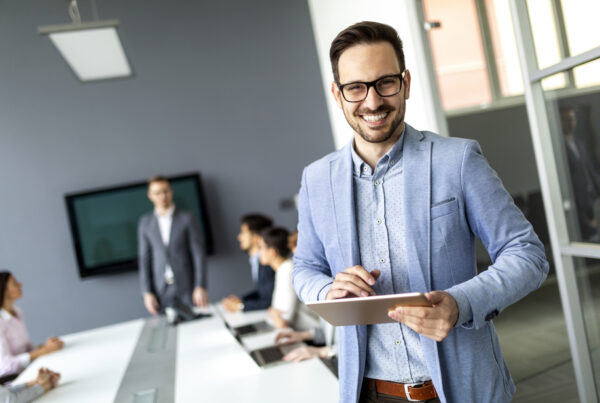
(0, 271, 63, 376)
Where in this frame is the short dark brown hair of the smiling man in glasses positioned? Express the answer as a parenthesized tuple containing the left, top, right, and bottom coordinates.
(329, 21, 405, 83)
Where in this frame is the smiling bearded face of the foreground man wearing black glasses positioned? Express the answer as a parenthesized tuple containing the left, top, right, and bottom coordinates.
(331, 42, 410, 143)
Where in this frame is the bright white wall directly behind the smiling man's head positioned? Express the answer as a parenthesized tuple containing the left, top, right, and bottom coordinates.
(308, 0, 447, 148)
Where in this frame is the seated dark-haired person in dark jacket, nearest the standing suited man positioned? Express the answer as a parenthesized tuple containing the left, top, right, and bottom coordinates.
(222, 214, 275, 312)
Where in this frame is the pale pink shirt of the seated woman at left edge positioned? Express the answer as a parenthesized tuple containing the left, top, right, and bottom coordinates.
(0, 307, 33, 376)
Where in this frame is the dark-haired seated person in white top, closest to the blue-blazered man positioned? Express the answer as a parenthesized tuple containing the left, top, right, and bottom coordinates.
(259, 228, 298, 328)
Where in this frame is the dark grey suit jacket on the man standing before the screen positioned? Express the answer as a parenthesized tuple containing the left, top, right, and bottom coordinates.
(138, 209, 206, 301)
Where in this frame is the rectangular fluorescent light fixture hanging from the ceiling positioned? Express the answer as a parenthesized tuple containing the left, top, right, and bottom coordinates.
(38, 20, 132, 81)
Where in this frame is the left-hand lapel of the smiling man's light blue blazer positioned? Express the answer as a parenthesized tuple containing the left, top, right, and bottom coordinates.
(329, 142, 360, 270)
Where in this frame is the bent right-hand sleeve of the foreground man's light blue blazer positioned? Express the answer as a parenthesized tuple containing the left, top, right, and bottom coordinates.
(447, 141, 549, 329)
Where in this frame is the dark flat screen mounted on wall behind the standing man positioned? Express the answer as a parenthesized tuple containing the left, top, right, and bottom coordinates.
(65, 173, 213, 277)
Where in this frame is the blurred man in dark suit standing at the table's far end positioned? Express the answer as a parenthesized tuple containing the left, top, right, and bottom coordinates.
(138, 176, 208, 315)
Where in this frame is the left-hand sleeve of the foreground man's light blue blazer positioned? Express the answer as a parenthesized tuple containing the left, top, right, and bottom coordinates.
(292, 168, 333, 302)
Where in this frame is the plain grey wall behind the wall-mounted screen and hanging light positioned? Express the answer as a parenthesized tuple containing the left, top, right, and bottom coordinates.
(0, 0, 333, 342)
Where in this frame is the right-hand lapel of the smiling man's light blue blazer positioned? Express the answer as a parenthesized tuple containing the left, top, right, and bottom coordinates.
(403, 125, 431, 292)
